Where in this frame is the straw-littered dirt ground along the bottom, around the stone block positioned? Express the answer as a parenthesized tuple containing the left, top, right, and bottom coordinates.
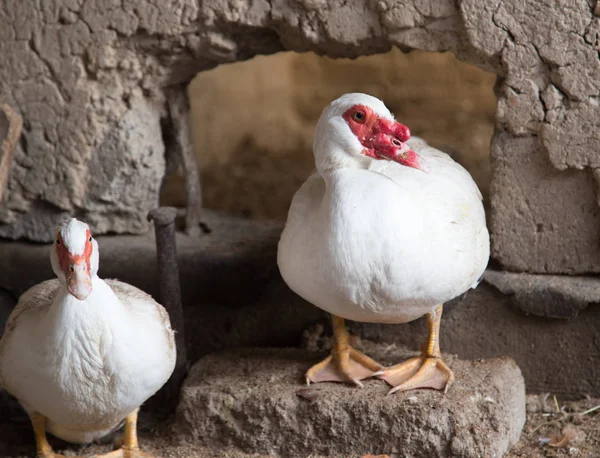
(0, 395, 600, 458)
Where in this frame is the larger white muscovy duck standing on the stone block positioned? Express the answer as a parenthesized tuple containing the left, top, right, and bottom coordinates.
(278, 93, 489, 393)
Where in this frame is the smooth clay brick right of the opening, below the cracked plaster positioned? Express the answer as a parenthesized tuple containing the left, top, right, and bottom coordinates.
(490, 133, 600, 275)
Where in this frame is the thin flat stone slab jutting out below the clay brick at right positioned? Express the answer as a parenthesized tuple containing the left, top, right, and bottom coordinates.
(483, 269, 600, 319)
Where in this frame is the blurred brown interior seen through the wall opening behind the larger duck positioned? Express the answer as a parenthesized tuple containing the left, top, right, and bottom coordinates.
(162, 49, 496, 220)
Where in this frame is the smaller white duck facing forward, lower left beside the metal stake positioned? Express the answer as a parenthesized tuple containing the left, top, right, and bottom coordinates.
(0, 219, 176, 458)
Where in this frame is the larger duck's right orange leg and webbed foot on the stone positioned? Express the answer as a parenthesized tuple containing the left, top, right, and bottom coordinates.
(380, 305, 454, 394)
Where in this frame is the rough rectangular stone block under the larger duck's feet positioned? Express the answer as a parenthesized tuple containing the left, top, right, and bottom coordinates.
(176, 346, 525, 457)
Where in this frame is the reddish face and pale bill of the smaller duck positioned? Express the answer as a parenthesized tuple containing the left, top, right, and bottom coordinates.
(55, 229, 94, 301)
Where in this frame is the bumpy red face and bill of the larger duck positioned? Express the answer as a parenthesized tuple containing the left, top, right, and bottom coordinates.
(342, 105, 425, 171)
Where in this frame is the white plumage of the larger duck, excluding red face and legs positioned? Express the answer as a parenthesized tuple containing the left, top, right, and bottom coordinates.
(278, 94, 489, 323)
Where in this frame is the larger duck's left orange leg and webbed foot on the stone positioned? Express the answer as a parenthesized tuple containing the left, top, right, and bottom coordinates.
(306, 315, 383, 387)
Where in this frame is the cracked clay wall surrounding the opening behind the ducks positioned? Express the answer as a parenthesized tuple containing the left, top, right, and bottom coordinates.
(0, 0, 600, 273)
